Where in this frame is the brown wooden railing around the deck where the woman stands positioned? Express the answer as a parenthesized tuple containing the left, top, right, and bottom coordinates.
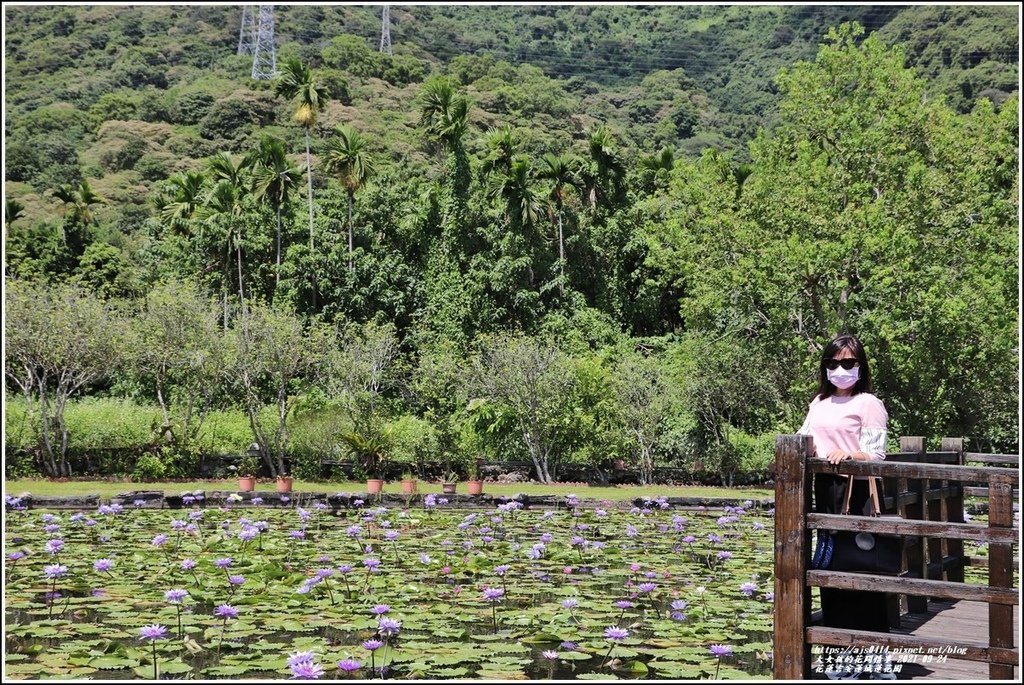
(773, 435, 1019, 680)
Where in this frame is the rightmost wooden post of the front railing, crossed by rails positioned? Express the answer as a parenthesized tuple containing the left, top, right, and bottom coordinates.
(988, 475, 1014, 680)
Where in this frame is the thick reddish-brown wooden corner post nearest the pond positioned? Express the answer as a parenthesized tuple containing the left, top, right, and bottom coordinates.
(772, 435, 813, 680)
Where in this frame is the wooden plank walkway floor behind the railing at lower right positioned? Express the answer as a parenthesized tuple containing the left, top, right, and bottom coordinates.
(893, 599, 1021, 681)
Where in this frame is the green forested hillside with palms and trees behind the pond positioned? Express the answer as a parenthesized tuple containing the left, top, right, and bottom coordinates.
(4, 5, 1019, 481)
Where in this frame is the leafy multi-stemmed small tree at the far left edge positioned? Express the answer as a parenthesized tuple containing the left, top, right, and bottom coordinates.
(4, 281, 125, 478)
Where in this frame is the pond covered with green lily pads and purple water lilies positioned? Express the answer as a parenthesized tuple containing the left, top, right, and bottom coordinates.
(4, 497, 773, 680)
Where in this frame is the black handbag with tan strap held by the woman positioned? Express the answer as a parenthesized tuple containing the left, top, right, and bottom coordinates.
(811, 476, 903, 575)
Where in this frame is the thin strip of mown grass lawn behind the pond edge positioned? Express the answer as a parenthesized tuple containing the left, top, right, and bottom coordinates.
(4, 478, 775, 500)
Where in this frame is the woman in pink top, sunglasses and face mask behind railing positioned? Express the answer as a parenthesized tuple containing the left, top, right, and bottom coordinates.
(798, 335, 889, 677)
